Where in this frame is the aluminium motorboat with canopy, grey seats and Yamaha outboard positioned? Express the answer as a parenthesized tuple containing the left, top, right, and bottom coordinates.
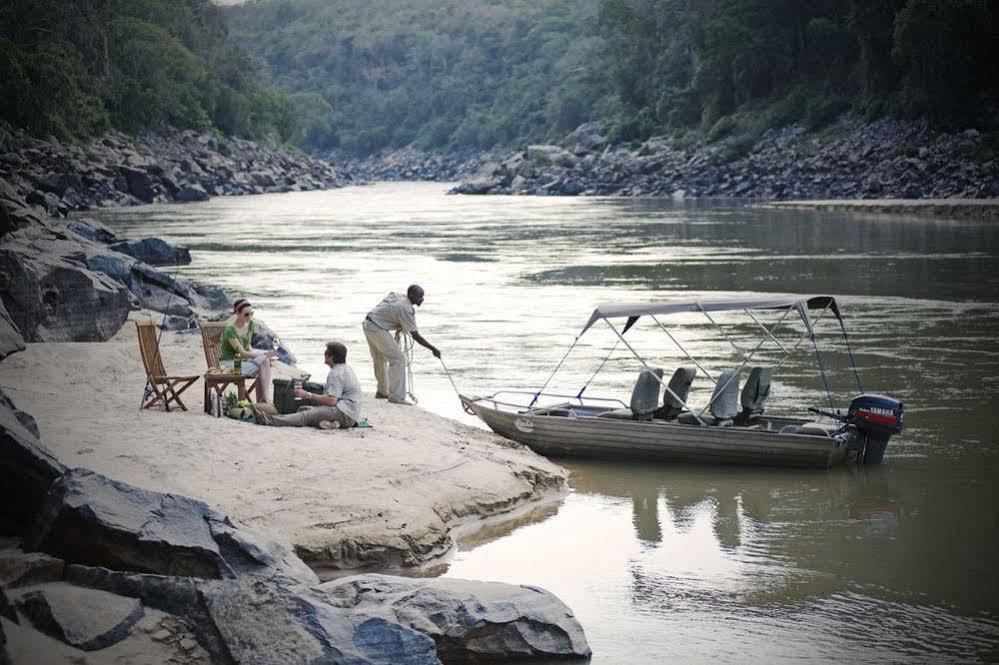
(459, 296, 904, 468)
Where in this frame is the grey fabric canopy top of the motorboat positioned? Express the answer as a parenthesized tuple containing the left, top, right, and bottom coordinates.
(579, 296, 843, 335)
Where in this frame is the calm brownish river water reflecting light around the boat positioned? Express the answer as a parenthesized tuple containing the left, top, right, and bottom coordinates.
(93, 183, 999, 664)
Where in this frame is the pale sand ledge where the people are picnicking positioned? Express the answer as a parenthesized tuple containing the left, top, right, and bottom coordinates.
(0, 322, 568, 568)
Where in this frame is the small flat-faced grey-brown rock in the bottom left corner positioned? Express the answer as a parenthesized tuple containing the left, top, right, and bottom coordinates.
(17, 582, 143, 651)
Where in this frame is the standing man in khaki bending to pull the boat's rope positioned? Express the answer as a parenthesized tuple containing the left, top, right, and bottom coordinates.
(361, 284, 441, 404)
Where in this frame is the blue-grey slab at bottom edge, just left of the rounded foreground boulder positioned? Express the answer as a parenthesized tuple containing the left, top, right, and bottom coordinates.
(197, 578, 440, 665)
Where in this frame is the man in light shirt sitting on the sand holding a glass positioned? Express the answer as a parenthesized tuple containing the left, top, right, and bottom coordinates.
(253, 342, 363, 429)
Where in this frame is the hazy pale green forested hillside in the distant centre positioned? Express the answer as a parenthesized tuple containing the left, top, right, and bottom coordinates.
(228, 0, 613, 153)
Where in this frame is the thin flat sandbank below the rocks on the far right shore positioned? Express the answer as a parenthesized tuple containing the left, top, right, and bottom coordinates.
(759, 199, 999, 222)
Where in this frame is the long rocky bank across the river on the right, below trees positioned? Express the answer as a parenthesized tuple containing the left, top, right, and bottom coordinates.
(452, 119, 999, 199)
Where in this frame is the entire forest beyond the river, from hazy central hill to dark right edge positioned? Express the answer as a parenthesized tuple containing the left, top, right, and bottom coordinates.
(227, 0, 999, 153)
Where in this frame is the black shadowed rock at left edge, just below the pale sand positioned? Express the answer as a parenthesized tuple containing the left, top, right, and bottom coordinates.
(0, 393, 66, 534)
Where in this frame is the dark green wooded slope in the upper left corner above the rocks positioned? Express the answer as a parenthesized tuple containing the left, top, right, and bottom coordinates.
(0, 0, 294, 138)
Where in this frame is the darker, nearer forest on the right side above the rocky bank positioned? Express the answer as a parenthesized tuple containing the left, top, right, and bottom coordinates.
(600, 0, 999, 138)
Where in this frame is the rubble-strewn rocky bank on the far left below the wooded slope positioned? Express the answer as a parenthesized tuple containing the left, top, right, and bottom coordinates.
(0, 123, 352, 218)
